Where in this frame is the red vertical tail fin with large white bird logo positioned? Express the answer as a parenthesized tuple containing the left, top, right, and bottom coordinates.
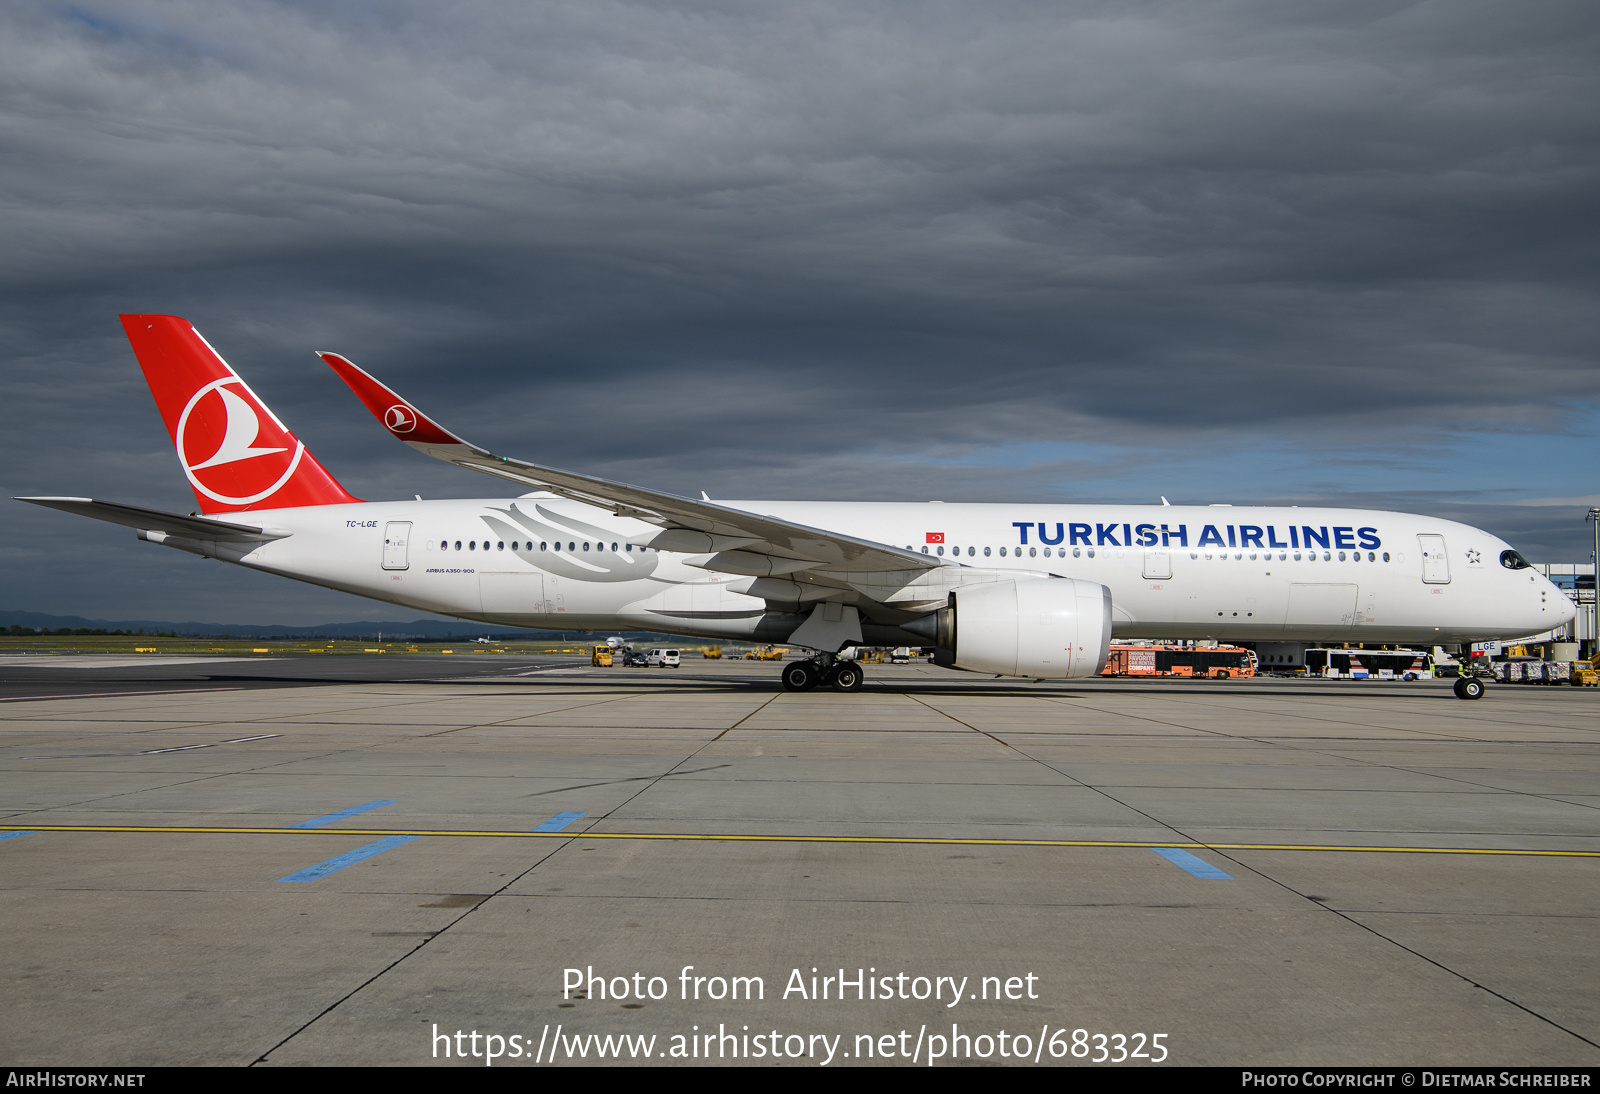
(118, 315, 360, 513)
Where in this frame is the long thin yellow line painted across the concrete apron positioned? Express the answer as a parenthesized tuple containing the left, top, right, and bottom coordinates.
(0, 824, 1600, 859)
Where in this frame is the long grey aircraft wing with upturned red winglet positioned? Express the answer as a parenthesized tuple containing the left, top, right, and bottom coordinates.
(318, 353, 952, 595)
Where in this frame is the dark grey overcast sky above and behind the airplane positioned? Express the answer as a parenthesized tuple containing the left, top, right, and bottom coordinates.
(0, 0, 1600, 624)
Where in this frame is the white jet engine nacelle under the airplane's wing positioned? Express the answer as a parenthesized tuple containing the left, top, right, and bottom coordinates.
(934, 577, 1110, 680)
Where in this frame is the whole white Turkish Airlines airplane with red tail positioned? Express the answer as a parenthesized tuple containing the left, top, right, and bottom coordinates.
(19, 315, 1574, 699)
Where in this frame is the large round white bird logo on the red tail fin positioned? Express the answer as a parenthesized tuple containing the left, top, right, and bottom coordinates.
(174, 376, 306, 505)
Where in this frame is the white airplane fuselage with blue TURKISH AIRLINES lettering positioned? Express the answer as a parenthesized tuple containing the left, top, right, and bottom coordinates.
(203, 496, 1573, 645)
